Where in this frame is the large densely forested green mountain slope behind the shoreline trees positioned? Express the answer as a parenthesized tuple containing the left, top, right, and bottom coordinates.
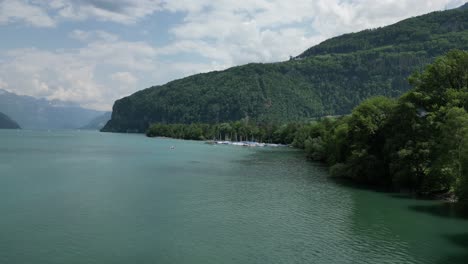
(103, 5, 468, 132)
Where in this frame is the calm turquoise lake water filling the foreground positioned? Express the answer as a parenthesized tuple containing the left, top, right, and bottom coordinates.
(0, 130, 468, 264)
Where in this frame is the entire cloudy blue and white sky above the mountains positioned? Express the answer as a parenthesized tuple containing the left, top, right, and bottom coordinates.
(0, 0, 466, 111)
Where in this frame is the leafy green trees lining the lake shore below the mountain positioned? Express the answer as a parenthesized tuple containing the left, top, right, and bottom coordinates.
(147, 50, 468, 200)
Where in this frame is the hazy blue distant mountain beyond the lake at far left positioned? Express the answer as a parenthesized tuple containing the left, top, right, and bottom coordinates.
(0, 89, 104, 129)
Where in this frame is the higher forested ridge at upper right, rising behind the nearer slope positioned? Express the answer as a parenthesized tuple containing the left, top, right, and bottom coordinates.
(298, 3, 468, 58)
